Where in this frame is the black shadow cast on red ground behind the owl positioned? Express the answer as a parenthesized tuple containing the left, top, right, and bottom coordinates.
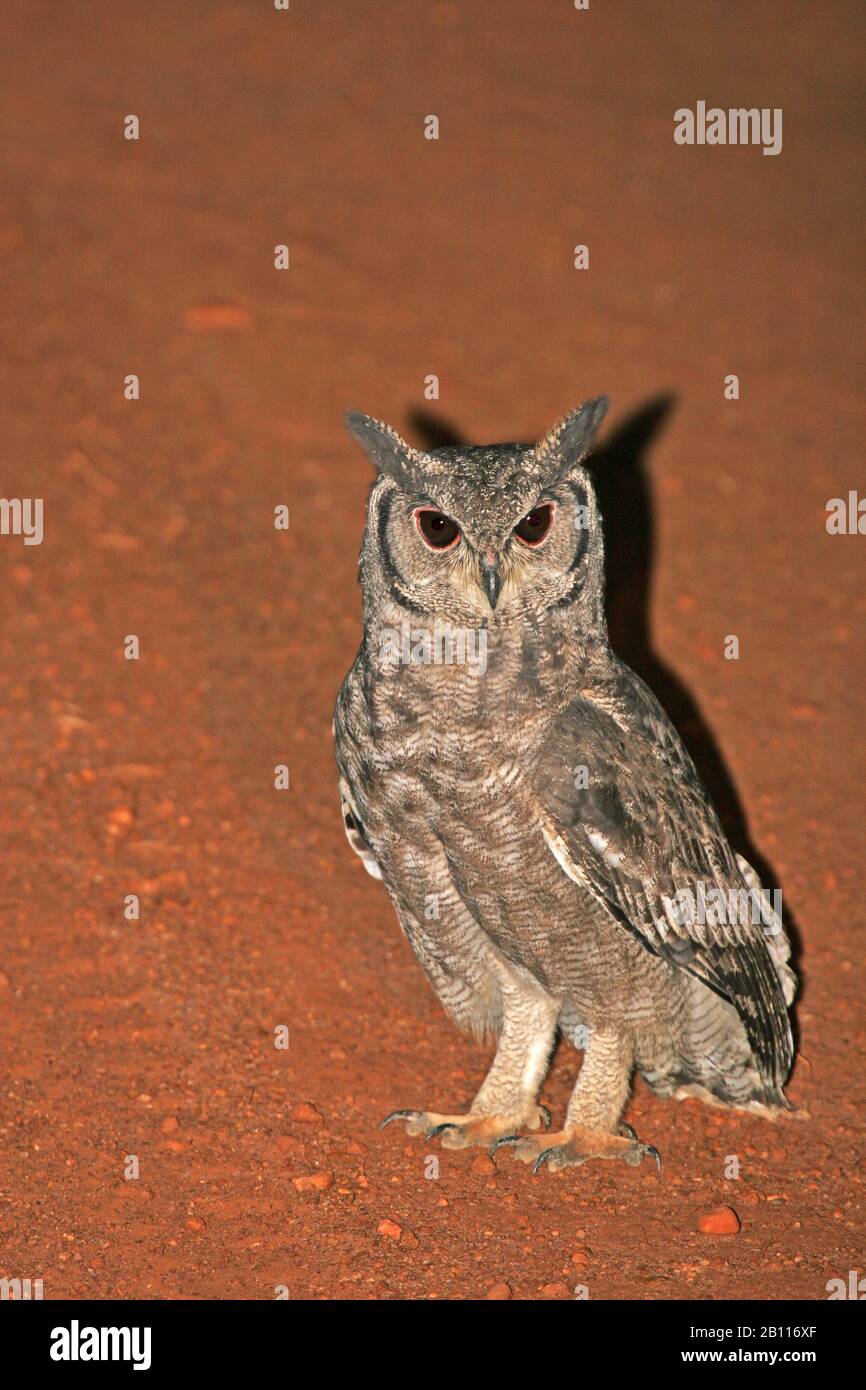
(410, 395, 799, 984)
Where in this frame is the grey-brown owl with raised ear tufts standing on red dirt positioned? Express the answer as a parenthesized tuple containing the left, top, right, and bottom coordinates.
(334, 398, 795, 1172)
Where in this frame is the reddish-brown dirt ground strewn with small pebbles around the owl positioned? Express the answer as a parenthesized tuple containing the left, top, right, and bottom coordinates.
(0, 0, 866, 1300)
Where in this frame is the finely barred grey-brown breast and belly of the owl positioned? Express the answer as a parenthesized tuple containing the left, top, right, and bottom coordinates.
(336, 650, 644, 1017)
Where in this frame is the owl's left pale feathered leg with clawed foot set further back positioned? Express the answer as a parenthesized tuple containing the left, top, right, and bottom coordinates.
(384, 966, 560, 1148)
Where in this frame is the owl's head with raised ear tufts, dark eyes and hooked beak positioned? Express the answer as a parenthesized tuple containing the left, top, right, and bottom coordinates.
(346, 396, 607, 626)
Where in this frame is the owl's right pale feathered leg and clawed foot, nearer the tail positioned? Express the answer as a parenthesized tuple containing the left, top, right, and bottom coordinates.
(496, 1030, 660, 1173)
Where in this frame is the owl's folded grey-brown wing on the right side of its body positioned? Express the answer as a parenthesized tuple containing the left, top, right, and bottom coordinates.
(532, 666, 792, 1104)
